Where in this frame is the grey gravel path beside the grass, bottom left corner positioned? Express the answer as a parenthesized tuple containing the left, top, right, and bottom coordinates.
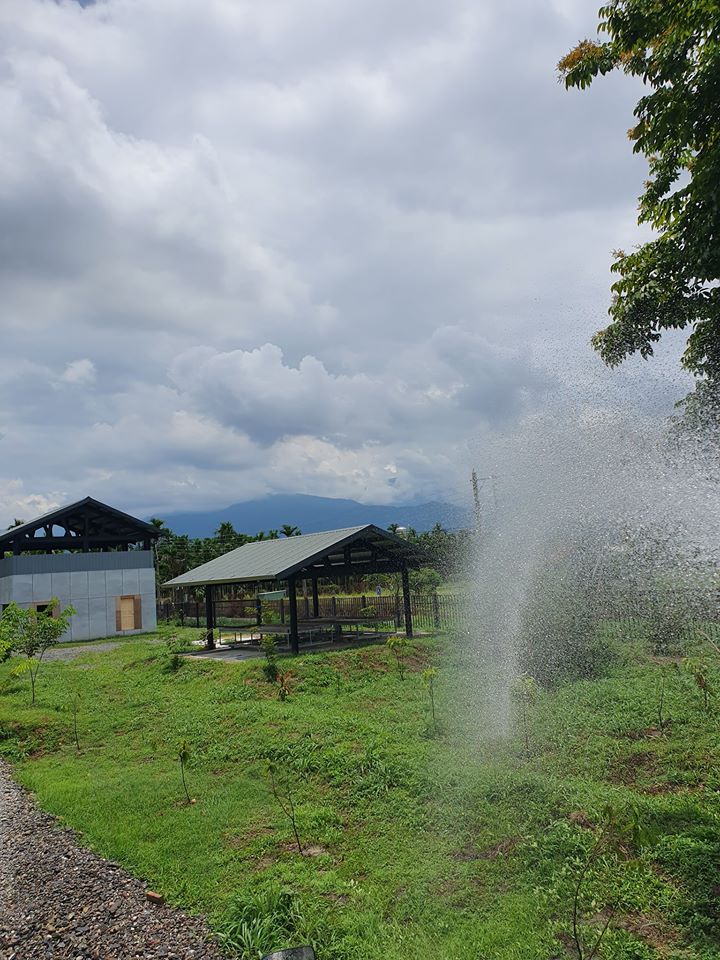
(0, 761, 221, 960)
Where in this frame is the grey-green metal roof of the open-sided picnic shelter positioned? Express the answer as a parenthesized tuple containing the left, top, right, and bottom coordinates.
(164, 523, 429, 587)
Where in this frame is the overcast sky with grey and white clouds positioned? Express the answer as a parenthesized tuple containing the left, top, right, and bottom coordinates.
(0, 0, 683, 525)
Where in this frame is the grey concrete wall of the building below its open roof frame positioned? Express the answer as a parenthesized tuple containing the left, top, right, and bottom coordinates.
(0, 550, 157, 640)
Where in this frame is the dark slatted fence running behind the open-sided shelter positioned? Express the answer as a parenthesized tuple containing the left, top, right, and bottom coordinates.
(157, 594, 467, 630)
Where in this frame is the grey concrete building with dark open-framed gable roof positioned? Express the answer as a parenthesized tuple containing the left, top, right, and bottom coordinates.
(0, 497, 158, 640)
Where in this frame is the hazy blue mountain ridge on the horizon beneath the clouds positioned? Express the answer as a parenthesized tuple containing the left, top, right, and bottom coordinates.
(156, 493, 470, 537)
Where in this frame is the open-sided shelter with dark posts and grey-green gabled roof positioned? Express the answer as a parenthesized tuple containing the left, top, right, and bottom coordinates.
(164, 524, 430, 653)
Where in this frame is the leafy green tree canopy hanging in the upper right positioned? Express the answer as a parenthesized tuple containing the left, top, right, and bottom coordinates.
(558, 0, 720, 383)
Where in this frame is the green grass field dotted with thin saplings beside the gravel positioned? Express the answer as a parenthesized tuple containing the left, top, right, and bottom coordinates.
(0, 637, 720, 960)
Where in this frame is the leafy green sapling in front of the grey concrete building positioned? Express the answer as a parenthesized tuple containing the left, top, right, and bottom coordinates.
(0, 598, 75, 703)
